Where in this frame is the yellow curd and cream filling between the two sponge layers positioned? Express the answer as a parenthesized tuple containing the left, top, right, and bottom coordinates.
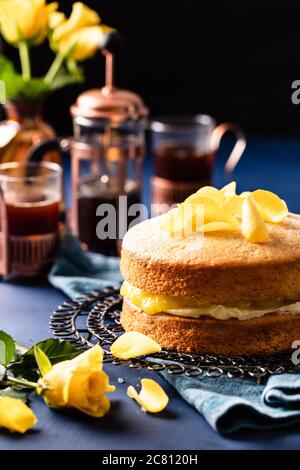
(121, 281, 300, 320)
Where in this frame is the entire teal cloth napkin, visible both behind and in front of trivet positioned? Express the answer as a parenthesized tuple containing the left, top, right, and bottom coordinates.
(49, 233, 300, 434)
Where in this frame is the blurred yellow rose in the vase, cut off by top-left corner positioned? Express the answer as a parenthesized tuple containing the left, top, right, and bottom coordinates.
(0, 0, 58, 45)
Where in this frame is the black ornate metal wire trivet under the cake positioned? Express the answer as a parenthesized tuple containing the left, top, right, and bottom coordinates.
(50, 287, 300, 382)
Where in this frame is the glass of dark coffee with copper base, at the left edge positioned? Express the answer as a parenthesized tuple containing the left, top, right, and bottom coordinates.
(0, 162, 62, 276)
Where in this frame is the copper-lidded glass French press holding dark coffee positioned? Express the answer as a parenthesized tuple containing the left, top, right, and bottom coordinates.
(30, 32, 148, 256)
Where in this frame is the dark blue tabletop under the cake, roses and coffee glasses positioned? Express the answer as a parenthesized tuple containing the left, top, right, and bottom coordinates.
(0, 134, 300, 449)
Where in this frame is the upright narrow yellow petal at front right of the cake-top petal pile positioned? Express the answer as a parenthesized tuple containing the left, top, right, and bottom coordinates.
(242, 194, 268, 243)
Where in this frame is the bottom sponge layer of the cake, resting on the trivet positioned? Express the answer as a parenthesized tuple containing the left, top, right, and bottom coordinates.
(121, 297, 300, 356)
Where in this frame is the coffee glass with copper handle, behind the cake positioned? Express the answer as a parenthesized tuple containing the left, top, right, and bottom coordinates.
(151, 114, 246, 209)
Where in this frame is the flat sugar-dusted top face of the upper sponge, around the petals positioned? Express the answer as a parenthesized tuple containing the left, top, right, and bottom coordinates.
(122, 213, 300, 269)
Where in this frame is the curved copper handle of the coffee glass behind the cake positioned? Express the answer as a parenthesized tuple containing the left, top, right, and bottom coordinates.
(211, 122, 246, 175)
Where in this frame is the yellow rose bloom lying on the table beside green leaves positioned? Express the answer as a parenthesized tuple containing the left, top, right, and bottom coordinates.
(38, 346, 115, 418)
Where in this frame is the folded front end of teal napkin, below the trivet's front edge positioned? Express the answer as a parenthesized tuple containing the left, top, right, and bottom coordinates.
(163, 372, 300, 434)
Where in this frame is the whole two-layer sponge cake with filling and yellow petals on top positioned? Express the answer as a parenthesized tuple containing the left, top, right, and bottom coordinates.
(121, 184, 300, 355)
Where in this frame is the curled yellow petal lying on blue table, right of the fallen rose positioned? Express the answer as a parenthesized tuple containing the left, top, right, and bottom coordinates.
(127, 379, 169, 413)
